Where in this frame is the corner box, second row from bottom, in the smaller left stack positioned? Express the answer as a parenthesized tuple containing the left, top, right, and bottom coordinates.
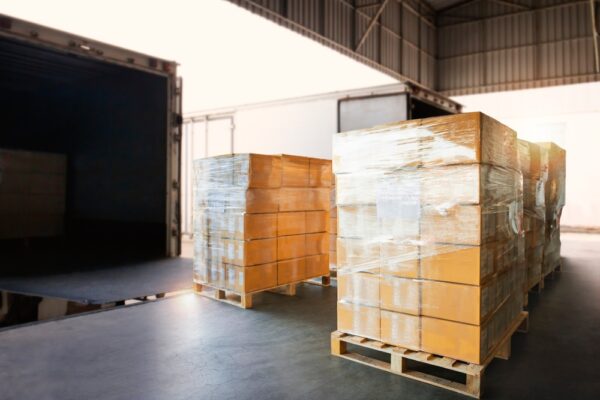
(220, 238, 277, 267)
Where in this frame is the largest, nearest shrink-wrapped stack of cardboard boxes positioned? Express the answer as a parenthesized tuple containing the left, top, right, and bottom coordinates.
(333, 113, 524, 364)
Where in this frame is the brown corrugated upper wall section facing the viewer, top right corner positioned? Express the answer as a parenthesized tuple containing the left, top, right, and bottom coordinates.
(437, 0, 600, 95)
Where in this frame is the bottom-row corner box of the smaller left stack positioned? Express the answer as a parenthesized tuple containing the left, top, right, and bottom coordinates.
(226, 263, 277, 293)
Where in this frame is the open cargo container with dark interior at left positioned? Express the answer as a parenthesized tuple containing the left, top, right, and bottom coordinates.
(0, 15, 183, 304)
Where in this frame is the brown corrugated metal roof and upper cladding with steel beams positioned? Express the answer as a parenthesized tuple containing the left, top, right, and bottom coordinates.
(229, 0, 600, 96)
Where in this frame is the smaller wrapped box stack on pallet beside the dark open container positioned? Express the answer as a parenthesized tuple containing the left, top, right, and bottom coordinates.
(194, 154, 331, 294)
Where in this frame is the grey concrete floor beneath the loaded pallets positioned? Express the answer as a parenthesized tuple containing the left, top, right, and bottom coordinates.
(0, 235, 600, 400)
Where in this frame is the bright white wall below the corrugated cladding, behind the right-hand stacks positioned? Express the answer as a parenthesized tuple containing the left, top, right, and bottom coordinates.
(454, 83, 600, 228)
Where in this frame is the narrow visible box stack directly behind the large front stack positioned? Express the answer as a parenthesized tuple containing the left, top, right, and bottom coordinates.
(519, 140, 546, 292)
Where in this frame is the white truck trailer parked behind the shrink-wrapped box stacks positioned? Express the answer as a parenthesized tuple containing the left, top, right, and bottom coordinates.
(182, 83, 462, 234)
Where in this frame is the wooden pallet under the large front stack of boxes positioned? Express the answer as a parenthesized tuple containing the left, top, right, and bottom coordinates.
(331, 311, 529, 398)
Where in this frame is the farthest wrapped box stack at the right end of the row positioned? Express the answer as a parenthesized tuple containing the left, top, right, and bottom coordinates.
(538, 143, 566, 276)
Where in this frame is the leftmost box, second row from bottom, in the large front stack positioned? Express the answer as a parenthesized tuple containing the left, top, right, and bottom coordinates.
(338, 272, 380, 307)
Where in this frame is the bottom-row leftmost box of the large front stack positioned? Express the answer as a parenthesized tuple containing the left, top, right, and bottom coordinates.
(337, 302, 381, 340)
